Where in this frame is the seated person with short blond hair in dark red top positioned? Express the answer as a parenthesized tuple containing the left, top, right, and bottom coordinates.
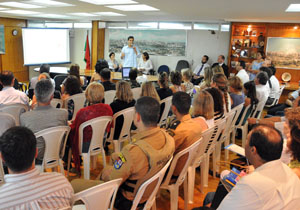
(69, 82, 113, 173)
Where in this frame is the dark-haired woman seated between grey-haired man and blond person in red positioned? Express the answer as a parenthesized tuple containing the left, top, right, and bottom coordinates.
(61, 75, 82, 120)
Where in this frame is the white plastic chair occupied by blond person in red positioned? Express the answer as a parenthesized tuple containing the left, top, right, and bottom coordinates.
(77, 116, 112, 179)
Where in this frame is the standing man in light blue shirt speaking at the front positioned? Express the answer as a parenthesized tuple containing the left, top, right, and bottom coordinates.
(121, 36, 141, 68)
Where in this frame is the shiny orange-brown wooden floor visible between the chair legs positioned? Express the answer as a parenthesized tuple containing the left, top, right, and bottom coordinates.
(65, 139, 242, 210)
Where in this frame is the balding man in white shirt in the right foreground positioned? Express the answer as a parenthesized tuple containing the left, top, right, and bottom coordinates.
(218, 125, 300, 210)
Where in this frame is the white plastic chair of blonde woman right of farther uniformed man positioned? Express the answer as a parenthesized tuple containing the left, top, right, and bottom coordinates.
(188, 127, 215, 203)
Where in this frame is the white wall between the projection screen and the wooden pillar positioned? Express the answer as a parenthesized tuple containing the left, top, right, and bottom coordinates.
(29, 29, 93, 79)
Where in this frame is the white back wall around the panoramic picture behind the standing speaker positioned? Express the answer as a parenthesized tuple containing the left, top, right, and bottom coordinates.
(105, 29, 230, 70)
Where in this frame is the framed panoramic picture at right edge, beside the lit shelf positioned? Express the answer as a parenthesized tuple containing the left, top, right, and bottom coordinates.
(266, 37, 300, 69)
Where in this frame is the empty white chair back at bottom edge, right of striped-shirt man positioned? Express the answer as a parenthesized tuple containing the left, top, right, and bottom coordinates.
(74, 179, 122, 210)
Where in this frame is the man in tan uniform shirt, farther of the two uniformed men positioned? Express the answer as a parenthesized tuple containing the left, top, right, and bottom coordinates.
(167, 92, 202, 178)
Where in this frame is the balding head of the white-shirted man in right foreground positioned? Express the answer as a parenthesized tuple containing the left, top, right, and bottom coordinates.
(248, 125, 283, 162)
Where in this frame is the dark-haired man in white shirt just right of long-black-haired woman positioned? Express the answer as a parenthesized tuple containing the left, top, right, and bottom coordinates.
(254, 71, 270, 102)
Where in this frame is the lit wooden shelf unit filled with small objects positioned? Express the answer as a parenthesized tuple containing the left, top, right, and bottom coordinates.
(228, 23, 266, 73)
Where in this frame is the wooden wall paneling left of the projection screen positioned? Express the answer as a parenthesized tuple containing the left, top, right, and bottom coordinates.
(0, 18, 29, 81)
